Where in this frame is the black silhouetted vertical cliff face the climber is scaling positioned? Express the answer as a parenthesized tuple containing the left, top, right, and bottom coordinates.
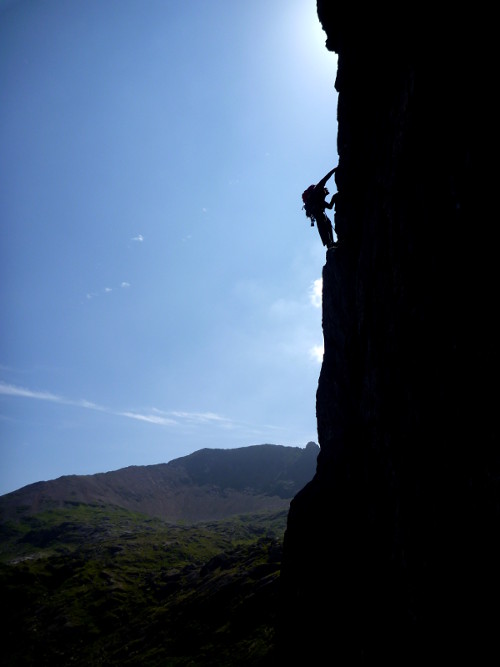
(279, 0, 500, 665)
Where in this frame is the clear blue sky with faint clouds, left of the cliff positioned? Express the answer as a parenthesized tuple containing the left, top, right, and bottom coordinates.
(0, 0, 337, 495)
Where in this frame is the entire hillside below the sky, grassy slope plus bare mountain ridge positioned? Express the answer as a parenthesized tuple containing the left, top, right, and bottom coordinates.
(0, 443, 319, 667)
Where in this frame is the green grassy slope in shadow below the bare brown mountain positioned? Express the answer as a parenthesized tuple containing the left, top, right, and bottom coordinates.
(0, 503, 287, 667)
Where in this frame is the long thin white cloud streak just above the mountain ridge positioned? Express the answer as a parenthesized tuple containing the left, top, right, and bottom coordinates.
(0, 381, 233, 428)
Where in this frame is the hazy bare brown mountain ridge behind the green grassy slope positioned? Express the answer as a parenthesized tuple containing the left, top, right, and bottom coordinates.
(0, 442, 319, 523)
